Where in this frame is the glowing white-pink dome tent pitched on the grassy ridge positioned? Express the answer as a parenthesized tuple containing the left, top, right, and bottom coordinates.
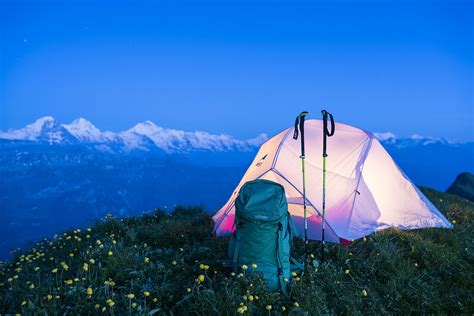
(213, 120, 452, 243)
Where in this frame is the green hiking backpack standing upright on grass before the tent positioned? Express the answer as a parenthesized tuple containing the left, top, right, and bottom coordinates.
(229, 180, 297, 295)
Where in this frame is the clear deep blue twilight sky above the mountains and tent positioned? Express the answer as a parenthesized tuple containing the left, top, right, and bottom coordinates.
(0, 0, 474, 141)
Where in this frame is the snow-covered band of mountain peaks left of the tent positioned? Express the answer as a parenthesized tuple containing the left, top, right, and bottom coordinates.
(0, 116, 268, 153)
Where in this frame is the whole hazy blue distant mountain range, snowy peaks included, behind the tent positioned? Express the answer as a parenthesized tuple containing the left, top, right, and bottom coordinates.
(0, 117, 474, 258)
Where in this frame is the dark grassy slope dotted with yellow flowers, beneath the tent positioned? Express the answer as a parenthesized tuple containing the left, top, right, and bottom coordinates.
(0, 189, 474, 315)
